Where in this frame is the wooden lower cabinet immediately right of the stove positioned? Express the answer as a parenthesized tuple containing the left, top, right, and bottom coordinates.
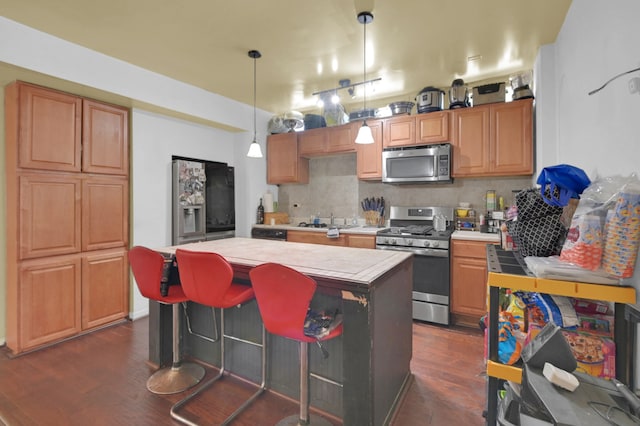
(451, 240, 490, 326)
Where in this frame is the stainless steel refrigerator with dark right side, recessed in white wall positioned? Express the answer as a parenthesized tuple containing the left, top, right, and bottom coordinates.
(172, 157, 236, 244)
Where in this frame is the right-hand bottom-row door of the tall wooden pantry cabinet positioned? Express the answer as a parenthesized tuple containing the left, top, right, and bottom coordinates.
(82, 250, 129, 330)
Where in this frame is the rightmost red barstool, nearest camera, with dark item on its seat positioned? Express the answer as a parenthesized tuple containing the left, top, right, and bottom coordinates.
(249, 263, 342, 426)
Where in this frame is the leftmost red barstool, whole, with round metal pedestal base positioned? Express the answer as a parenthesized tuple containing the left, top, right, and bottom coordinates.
(129, 246, 204, 394)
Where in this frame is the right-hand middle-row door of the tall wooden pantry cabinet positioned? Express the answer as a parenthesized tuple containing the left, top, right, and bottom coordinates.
(82, 176, 129, 251)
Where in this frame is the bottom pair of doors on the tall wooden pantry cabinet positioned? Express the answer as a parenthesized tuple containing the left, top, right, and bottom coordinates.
(7, 248, 129, 353)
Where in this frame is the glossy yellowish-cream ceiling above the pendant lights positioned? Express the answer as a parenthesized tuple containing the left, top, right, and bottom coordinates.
(0, 0, 571, 114)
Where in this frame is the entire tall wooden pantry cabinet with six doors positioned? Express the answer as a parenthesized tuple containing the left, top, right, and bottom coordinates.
(5, 82, 129, 354)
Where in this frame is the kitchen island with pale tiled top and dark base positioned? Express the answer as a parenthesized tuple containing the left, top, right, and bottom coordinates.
(149, 238, 413, 426)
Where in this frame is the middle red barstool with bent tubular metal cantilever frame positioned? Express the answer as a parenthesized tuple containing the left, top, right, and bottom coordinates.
(171, 249, 266, 425)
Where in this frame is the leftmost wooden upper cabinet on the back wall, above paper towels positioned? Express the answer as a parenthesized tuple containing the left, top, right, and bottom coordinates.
(267, 132, 309, 185)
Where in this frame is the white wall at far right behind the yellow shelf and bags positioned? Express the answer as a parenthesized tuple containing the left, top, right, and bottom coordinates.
(535, 0, 640, 388)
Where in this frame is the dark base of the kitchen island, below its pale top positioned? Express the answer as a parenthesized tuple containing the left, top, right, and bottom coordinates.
(149, 257, 413, 426)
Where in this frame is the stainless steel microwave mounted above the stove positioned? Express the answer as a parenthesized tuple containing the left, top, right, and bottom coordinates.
(382, 143, 453, 183)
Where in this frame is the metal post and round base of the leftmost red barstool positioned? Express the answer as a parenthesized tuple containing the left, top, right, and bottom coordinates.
(147, 303, 205, 395)
